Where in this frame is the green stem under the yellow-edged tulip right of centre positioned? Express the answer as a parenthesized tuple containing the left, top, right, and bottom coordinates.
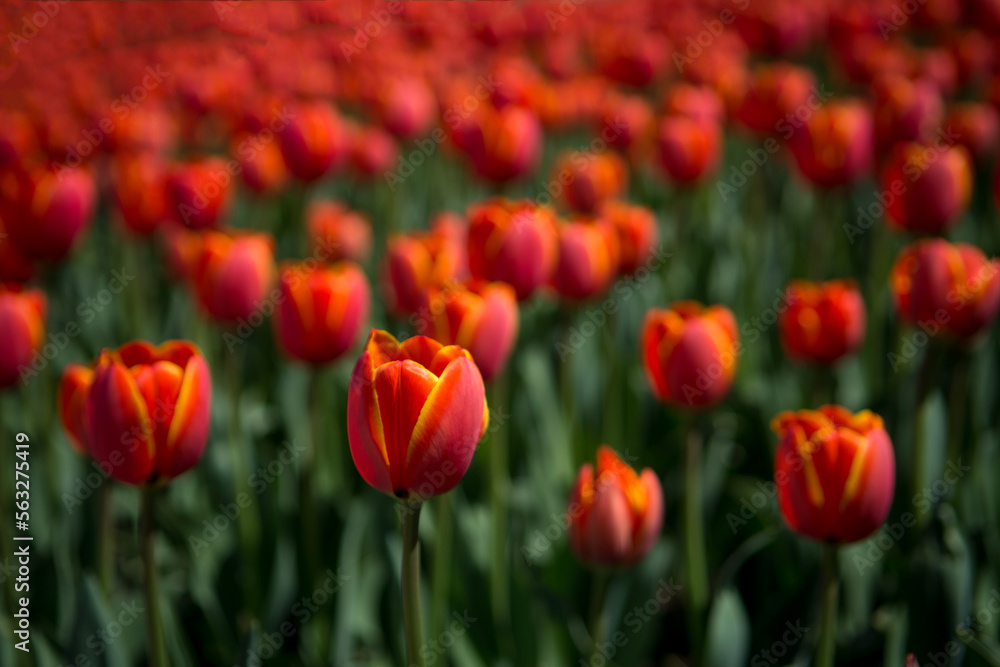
(684, 415, 708, 657)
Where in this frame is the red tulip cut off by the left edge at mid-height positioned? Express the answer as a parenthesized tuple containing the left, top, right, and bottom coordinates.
(0, 283, 48, 389)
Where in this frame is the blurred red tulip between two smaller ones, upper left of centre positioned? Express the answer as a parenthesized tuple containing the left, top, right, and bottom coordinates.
(277, 102, 350, 182)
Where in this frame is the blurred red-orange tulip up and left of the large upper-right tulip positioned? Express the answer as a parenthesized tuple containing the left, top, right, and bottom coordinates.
(789, 100, 875, 188)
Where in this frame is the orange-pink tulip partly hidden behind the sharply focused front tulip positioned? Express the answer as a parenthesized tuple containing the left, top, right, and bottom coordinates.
(416, 280, 519, 382)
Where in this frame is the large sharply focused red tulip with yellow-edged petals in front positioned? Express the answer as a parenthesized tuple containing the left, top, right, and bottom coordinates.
(347, 329, 490, 499)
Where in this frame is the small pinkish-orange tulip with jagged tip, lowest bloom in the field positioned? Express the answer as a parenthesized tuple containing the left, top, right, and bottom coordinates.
(569, 445, 663, 567)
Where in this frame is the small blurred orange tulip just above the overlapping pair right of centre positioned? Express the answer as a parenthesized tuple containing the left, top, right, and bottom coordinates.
(552, 151, 628, 213)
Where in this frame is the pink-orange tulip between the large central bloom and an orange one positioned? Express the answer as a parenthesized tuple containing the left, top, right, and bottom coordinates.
(552, 221, 618, 300)
